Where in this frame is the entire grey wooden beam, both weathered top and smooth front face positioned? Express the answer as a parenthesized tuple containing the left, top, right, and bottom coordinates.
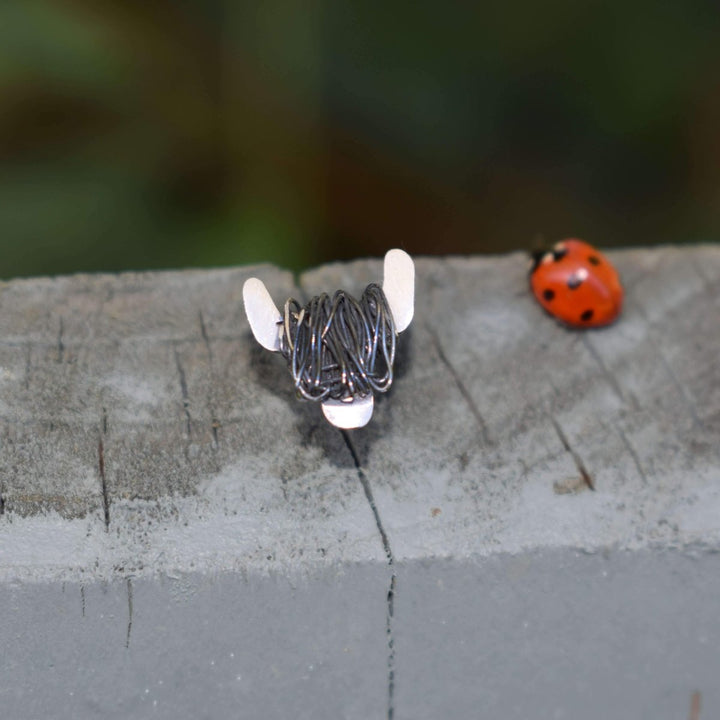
(0, 246, 720, 720)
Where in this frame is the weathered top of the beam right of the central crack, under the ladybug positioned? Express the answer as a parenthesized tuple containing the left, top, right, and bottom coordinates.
(304, 246, 720, 559)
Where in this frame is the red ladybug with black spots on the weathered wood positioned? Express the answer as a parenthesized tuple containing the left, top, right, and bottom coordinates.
(530, 238, 623, 328)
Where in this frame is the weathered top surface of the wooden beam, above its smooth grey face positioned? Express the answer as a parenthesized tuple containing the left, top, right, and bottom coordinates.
(0, 246, 720, 577)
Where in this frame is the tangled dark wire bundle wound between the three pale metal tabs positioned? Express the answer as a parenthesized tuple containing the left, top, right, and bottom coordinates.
(280, 283, 396, 402)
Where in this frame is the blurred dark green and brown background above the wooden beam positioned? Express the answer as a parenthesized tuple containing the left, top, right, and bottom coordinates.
(0, 0, 720, 277)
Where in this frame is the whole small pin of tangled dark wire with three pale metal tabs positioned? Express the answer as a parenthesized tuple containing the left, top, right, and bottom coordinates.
(243, 249, 415, 429)
